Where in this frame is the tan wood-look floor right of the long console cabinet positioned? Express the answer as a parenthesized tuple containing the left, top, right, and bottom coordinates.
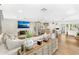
(55, 35, 79, 55)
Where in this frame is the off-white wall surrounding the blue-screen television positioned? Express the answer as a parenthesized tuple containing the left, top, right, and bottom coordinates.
(2, 19, 37, 34)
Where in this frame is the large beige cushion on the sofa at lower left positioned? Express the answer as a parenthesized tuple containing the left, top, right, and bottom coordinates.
(6, 39, 25, 50)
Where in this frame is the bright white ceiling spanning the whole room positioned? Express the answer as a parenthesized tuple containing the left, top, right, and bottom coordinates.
(1, 4, 79, 21)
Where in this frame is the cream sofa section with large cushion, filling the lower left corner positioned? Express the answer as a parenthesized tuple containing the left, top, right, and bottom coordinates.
(0, 34, 25, 55)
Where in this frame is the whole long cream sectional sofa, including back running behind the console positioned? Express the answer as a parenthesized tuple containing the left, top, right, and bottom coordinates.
(0, 34, 54, 55)
